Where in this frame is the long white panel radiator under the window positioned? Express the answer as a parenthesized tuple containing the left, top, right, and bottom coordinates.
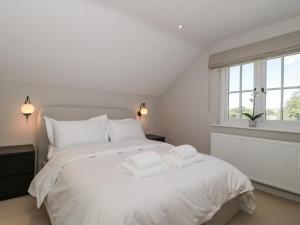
(211, 133, 300, 194)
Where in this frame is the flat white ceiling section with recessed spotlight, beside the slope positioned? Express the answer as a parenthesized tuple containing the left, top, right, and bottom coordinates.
(96, 0, 300, 46)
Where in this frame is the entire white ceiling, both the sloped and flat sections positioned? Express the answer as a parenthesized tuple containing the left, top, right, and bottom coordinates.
(0, 0, 300, 95)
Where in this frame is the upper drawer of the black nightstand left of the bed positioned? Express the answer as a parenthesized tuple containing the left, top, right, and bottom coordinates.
(0, 152, 34, 179)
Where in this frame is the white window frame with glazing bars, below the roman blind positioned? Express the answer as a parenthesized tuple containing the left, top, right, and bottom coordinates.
(219, 52, 300, 133)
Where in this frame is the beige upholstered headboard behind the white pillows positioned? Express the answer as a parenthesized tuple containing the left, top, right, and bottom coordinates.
(36, 107, 134, 172)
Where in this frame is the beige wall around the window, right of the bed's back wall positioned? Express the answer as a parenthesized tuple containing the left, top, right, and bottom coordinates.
(160, 17, 300, 153)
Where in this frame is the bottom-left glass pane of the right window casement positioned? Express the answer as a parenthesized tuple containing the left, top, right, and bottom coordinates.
(266, 90, 281, 120)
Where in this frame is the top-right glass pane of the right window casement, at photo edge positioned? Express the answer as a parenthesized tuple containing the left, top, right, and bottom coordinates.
(284, 54, 300, 87)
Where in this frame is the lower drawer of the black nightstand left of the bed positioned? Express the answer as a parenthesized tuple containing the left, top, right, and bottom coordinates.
(0, 174, 33, 200)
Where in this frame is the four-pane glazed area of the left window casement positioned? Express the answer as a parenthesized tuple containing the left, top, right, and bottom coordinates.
(228, 63, 254, 119)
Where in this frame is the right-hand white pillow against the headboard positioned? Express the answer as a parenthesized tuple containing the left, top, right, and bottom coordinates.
(107, 119, 146, 142)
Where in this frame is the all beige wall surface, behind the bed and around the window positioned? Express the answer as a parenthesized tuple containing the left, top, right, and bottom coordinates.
(0, 17, 300, 149)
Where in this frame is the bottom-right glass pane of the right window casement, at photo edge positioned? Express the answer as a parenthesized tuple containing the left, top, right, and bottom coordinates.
(283, 88, 300, 120)
